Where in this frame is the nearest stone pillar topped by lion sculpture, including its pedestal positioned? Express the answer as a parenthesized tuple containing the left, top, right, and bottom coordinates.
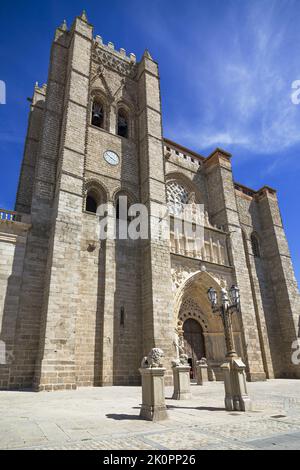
(139, 348, 168, 421)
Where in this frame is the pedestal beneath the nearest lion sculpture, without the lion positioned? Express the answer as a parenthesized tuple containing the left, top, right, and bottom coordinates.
(139, 367, 168, 421)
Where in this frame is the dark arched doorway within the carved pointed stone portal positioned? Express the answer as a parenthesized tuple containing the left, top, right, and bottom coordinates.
(183, 318, 205, 379)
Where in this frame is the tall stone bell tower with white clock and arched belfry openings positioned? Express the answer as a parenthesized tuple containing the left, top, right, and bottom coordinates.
(10, 13, 173, 390)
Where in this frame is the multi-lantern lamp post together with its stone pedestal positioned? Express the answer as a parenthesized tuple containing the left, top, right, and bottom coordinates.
(207, 285, 251, 411)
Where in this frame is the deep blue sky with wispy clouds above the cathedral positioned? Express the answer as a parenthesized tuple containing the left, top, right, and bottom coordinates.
(0, 0, 300, 281)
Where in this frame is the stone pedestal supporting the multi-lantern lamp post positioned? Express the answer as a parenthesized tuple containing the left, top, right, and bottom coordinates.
(221, 358, 252, 411)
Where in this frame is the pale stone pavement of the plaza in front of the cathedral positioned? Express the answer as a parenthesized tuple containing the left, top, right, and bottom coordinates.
(0, 380, 300, 450)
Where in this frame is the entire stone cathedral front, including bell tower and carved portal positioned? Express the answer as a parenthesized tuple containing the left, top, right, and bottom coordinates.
(0, 13, 300, 390)
